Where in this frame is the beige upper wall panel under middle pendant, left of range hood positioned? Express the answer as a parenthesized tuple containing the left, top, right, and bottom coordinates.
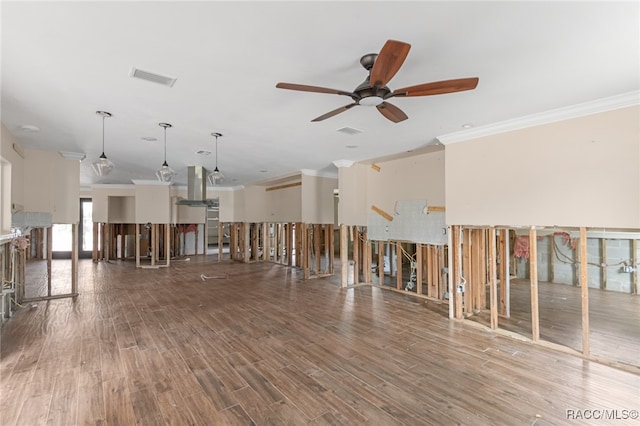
(135, 182, 171, 223)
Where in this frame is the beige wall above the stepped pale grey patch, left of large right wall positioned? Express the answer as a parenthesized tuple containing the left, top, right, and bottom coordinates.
(367, 149, 445, 214)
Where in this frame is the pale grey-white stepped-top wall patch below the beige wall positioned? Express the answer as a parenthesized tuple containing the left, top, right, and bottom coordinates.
(367, 200, 447, 245)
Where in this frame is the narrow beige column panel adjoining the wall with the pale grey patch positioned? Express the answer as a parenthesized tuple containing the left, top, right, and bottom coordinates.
(338, 163, 370, 226)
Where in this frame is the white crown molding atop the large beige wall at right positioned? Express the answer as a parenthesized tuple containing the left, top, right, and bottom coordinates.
(437, 90, 640, 145)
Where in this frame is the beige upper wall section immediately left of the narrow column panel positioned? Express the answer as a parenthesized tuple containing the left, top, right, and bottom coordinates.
(301, 174, 338, 224)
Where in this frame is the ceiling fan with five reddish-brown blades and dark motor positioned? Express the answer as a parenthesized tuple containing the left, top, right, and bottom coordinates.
(276, 40, 478, 123)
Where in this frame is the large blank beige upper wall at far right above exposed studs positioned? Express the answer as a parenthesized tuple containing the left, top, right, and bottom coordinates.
(446, 106, 640, 228)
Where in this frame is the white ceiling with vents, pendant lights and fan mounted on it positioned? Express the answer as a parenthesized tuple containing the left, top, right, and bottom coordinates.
(0, 1, 640, 186)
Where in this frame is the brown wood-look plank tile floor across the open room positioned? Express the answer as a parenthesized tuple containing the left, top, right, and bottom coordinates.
(0, 256, 640, 426)
